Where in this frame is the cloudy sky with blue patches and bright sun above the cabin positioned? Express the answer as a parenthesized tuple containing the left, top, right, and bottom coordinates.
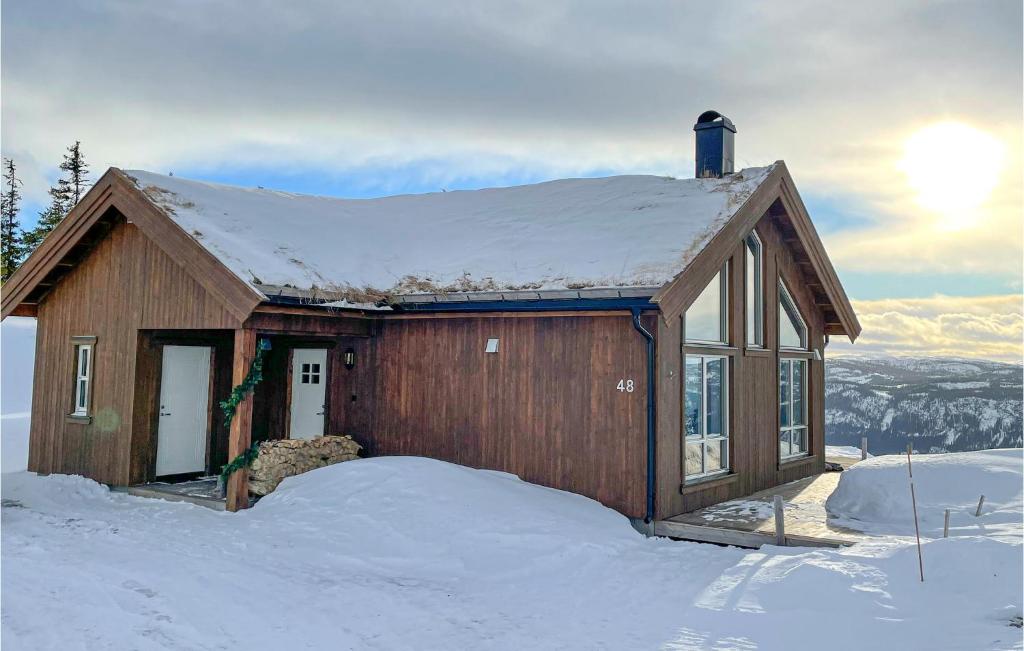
(0, 0, 1024, 361)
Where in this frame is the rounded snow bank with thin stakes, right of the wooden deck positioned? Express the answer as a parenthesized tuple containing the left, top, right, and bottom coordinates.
(825, 448, 1024, 537)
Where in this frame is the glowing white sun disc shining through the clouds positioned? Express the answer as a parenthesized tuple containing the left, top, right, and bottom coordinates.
(899, 122, 1005, 227)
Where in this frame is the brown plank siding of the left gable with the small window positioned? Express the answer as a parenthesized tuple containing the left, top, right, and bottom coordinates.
(29, 221, 239, 484)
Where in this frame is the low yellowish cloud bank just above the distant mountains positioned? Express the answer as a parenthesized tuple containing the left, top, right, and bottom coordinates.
(828, 295, 1024, 362)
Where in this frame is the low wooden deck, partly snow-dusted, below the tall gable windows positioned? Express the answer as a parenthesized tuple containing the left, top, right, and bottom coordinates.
(654, 459, 870, 549)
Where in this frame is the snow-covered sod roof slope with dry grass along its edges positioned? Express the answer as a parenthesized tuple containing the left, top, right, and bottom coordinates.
(125, 166, 772, 298)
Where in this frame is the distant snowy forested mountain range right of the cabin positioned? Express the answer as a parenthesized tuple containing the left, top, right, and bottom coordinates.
(825, 357, 1024, 454)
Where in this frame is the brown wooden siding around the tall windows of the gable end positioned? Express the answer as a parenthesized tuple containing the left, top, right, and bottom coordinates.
(656, 214, 824, 518)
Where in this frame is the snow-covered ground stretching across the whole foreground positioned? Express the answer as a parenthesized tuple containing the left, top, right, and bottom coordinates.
(2, 452, 1024, 650)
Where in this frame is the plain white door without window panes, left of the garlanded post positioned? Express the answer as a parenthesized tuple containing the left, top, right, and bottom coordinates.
(157, 346, 210, 477)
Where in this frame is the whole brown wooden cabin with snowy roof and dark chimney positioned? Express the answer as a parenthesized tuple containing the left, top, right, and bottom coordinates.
(2, 112, 860, 522)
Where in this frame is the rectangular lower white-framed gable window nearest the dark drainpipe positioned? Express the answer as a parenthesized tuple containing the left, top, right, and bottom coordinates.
(683, 355, 729, 479)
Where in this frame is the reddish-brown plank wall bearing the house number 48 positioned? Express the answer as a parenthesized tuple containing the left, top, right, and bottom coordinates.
(356, 313, 646, 517)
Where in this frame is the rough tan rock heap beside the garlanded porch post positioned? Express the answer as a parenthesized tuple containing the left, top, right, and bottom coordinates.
(249, 436, 361, 495)
